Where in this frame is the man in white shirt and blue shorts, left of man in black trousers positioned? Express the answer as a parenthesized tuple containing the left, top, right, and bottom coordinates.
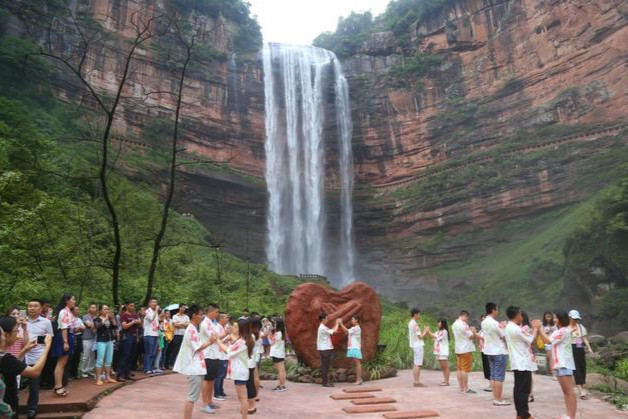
(481, 303, 510, 406)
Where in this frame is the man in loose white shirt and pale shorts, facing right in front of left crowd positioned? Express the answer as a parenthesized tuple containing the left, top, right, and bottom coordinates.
(172, 304, 211, 419)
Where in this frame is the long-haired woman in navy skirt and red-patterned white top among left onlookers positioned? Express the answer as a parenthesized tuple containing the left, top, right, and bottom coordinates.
(50, 292, 76, 397)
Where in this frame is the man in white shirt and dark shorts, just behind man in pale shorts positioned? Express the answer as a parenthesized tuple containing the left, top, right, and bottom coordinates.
(200, 304, 224, 413)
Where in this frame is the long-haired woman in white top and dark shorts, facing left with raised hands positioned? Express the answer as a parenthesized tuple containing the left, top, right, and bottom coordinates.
(216, 318, 255, 419)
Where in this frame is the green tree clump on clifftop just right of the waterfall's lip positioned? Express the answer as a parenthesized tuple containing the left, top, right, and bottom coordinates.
(313, 12, 373, 58)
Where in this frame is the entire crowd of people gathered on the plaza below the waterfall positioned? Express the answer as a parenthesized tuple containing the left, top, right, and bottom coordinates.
(0, 294, 593, 419)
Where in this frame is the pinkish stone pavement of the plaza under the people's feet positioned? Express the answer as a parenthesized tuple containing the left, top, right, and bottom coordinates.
(84, 371, 628, 419)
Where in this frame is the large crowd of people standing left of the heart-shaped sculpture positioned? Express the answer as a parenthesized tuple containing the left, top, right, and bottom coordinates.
(0, 294, 286, 418)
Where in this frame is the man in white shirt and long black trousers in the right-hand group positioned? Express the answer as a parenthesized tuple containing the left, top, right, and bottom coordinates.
(502, 306, 541, 419)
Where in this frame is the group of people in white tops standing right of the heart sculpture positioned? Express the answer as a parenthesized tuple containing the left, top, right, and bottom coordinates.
(408, 302, 593, 419)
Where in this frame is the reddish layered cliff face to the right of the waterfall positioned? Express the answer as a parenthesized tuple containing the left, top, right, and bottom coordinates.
(343, 0, 628, 305)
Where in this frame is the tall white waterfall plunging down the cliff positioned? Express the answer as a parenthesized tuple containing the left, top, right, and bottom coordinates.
(263, 44, 354, 284)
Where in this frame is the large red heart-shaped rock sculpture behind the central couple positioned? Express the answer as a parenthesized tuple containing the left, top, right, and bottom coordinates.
(286, 282, 382, 368)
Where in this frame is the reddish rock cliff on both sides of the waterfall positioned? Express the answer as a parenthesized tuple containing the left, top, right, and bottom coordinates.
(13, 0, 628, 314)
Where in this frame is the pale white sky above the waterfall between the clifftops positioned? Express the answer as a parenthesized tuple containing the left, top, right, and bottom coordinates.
(249, 0, 389, 45)
